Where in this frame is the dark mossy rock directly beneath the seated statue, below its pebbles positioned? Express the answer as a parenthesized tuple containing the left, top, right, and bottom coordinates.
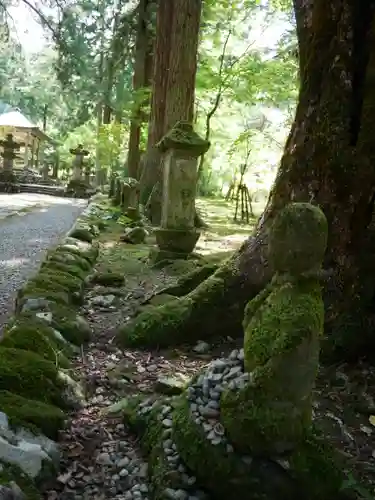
(173, 397, 345, 500)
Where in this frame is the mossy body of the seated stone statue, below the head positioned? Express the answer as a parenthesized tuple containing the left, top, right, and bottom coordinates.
(222, 280, 324, 455)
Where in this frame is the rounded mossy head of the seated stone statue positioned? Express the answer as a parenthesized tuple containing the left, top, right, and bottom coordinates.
(269, 203, 328, 275)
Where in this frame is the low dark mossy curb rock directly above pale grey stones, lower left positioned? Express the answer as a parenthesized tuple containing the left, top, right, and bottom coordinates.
(0, 390, 67, 441)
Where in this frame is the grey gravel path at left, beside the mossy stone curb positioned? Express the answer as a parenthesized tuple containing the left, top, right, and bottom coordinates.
(0, 194, 87, 332)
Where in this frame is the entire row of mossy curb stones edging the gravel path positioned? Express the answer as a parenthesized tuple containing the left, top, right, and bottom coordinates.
(0, 197, 103, 500)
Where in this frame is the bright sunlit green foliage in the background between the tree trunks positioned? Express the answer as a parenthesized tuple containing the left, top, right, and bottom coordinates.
(0, 0, 298, 190)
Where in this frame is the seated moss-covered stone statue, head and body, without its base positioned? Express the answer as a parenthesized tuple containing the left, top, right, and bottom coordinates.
(221, 203, 328, 456)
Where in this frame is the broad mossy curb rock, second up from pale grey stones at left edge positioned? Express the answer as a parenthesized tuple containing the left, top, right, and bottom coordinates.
(0, 347, 66, 408)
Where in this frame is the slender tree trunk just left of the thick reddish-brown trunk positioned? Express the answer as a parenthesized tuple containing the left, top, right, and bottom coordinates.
(127, 0, 153, 179)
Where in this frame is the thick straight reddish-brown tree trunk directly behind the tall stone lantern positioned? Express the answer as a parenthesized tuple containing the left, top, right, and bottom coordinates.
(141, 0, 202, 224)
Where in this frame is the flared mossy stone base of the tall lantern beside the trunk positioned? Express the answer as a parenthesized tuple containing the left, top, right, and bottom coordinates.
(150, 228, 201, 261)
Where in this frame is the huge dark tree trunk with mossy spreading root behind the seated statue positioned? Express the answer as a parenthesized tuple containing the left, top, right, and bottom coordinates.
(118, 0, 375, 366)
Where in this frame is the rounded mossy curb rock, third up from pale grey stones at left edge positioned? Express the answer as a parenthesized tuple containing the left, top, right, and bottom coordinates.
(0, 321, 70, 368)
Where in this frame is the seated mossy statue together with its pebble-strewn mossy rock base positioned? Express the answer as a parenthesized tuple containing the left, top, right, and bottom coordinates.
(119, 203, 351, 500)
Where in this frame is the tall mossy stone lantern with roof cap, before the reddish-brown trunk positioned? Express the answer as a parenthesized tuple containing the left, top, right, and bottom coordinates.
(153, 122, 210, 259)
